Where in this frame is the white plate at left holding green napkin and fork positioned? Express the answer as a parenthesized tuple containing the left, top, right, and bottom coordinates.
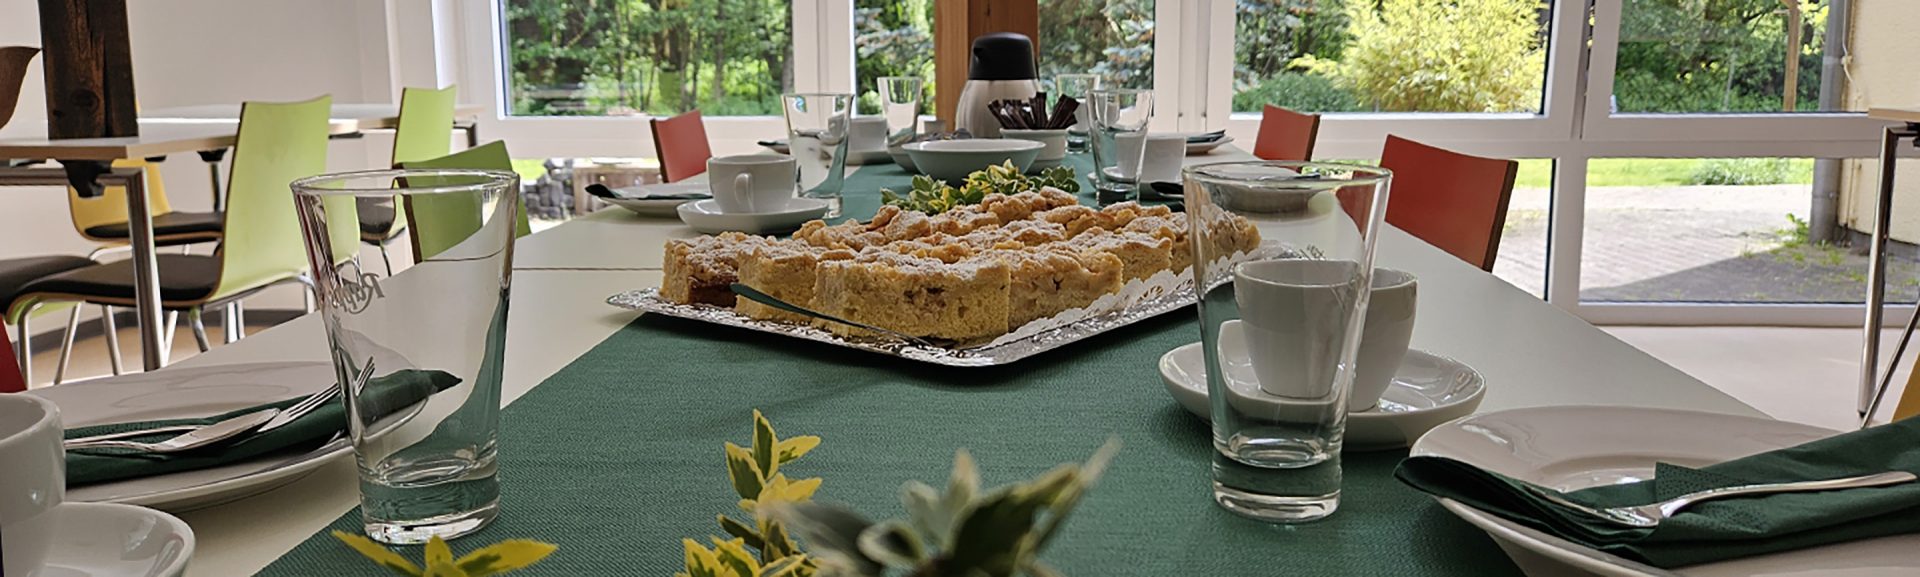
(31, 362, 353, 512)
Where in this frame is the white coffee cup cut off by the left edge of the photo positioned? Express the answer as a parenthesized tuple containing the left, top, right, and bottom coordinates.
(0, 393, 67, 575)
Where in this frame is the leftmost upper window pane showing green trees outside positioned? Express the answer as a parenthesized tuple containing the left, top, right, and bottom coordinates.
(501, 0, 793, 117)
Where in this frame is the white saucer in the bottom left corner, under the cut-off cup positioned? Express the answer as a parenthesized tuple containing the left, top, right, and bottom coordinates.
(38, 502, 194, 577)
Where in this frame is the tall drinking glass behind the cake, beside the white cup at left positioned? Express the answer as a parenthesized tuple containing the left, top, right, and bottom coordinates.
(781, 94, 852, 219)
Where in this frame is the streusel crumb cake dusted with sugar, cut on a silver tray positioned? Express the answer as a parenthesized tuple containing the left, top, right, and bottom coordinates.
(660, 188, 1260, 343)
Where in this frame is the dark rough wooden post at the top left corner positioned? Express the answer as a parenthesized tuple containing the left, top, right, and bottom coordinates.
(40, 0, 140, 138)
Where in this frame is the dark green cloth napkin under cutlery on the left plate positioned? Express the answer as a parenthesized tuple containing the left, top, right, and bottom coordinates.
(65, 370, 461, 487)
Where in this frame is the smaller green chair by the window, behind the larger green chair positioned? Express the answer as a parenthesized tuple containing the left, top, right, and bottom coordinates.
(359, 86, 455, 274)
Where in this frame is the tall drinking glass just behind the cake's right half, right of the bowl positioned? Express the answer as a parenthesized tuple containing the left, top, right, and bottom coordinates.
(1087, 88, 1154, 205)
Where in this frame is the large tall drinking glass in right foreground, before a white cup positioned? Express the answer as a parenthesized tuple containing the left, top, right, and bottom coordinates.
(1187, 161, 1390, 523)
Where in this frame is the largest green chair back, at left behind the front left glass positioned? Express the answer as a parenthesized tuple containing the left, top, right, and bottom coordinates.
(211, 96, 341, 299)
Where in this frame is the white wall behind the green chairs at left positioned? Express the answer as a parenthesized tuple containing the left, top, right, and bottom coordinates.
(0, 0, 412, 337)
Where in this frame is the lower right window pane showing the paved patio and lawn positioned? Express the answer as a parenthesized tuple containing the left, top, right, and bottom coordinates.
(1580, 159, 1920, 303)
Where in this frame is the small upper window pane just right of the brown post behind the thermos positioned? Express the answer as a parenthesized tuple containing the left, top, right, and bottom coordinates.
(1035, 0, 1154, 88)
